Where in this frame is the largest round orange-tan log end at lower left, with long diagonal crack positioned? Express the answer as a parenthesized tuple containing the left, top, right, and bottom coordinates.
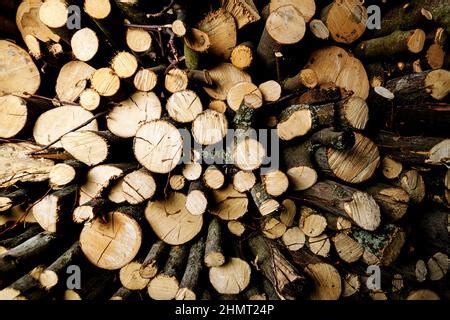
(80, 208, 142, 270)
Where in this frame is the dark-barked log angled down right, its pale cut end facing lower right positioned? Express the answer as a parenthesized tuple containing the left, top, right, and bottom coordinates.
(296, 180, 381, 231)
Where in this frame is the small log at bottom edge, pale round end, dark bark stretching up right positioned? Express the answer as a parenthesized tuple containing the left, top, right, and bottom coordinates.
(147, 245, 189, 300)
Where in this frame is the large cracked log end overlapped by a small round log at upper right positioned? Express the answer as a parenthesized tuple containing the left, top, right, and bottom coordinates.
(145, 192, 203, 245)
